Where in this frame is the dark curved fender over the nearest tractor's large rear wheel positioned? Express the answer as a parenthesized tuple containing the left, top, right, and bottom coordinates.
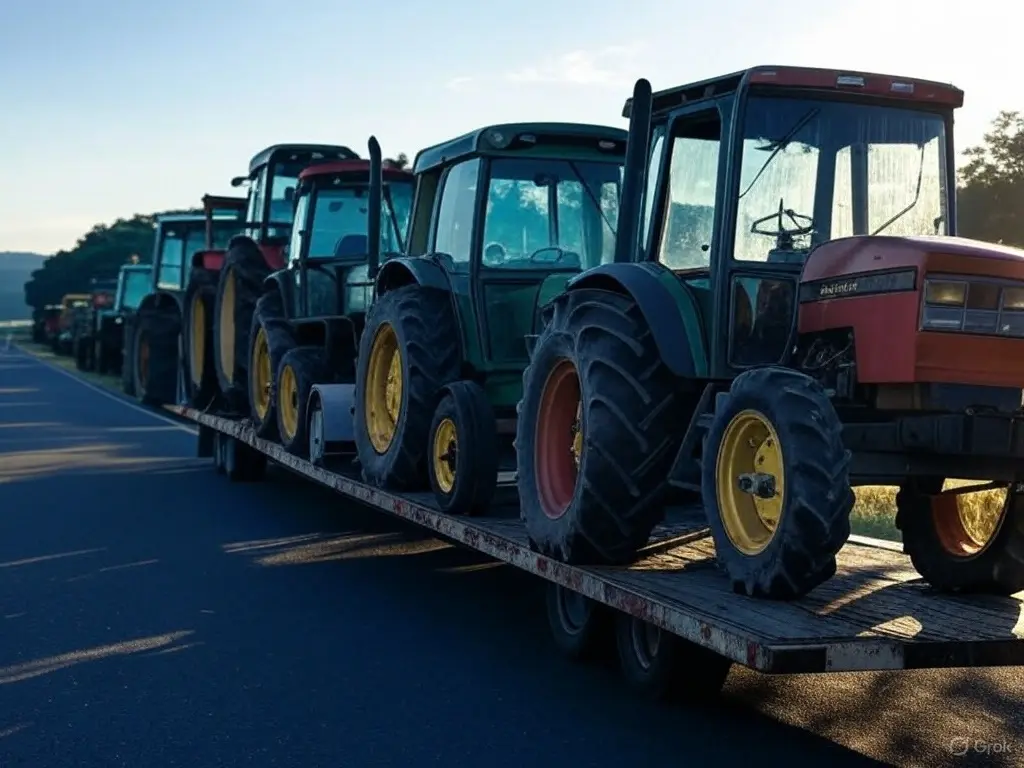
(566, 262, 708, 379)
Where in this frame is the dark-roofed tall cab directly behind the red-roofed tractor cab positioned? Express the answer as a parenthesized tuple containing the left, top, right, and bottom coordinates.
(231, 144, 358, 269)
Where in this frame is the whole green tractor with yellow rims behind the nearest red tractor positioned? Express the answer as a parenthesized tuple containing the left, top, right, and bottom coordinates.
(353, 123, 626, 514)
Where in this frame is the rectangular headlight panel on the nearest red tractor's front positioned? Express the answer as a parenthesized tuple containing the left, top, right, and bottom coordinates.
(921, 276, 1024, 337)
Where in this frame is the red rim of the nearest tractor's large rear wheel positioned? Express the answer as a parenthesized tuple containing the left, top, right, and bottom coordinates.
(535, 359, 580, 520)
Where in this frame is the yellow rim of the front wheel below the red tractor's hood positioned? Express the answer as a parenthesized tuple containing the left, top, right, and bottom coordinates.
(715, 410, 785, 555)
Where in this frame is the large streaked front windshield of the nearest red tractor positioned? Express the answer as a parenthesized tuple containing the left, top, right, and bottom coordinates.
(733, 96, 950, 261)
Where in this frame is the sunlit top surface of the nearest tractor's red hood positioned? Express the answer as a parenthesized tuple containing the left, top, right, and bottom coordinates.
(801, 236, 1024, 283)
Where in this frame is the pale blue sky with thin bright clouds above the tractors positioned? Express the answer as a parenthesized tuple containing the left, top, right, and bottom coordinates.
(0, 0, 1024, 253)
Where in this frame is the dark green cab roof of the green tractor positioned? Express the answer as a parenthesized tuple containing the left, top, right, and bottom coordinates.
(413, 123, 628, 174)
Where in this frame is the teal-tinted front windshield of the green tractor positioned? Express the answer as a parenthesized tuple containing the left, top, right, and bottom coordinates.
(482, 158, 623, 269)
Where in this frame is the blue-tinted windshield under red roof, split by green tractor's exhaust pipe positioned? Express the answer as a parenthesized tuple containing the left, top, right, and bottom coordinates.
(308, 181, 414, 260)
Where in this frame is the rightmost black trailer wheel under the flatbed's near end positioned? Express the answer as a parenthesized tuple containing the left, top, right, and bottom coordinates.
(615, 613, 732, 703)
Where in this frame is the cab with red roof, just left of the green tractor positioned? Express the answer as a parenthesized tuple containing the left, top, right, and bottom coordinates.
(288, 160, 414, 327)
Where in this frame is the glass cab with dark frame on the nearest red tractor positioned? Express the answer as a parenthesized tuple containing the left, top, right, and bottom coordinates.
(616, 67, 963, 379)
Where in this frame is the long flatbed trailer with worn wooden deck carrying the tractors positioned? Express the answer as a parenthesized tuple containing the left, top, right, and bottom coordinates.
(165, 406, 1024, 674)
